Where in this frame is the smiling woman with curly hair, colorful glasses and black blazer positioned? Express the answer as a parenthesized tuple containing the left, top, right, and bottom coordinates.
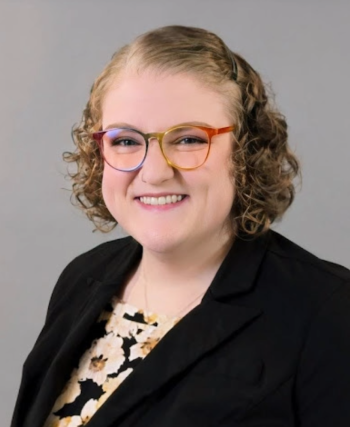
(12, 26, 350, 427)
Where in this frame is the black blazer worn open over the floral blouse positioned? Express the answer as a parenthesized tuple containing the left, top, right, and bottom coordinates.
(11, 231, 350, 427)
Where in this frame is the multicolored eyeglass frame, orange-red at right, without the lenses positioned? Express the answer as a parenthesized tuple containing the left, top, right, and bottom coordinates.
(91, 124, 235, 172)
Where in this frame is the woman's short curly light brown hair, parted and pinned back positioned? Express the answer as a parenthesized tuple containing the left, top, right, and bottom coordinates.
(63, 25, 300, 236)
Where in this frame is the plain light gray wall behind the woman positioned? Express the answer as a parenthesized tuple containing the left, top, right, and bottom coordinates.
(0, 0, 350, 426)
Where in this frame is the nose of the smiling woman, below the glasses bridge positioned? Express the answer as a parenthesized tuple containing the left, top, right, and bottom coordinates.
(140, 137, 174, 185)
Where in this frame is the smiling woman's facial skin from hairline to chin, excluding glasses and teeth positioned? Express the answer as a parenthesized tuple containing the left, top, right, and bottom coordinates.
(102, 72, 234, 253)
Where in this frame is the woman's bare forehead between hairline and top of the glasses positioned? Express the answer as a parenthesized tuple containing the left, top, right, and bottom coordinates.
(102, 72, 231, 132)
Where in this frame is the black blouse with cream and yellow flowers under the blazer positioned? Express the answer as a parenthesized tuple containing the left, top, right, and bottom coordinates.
(44, 297, 180, 427)
